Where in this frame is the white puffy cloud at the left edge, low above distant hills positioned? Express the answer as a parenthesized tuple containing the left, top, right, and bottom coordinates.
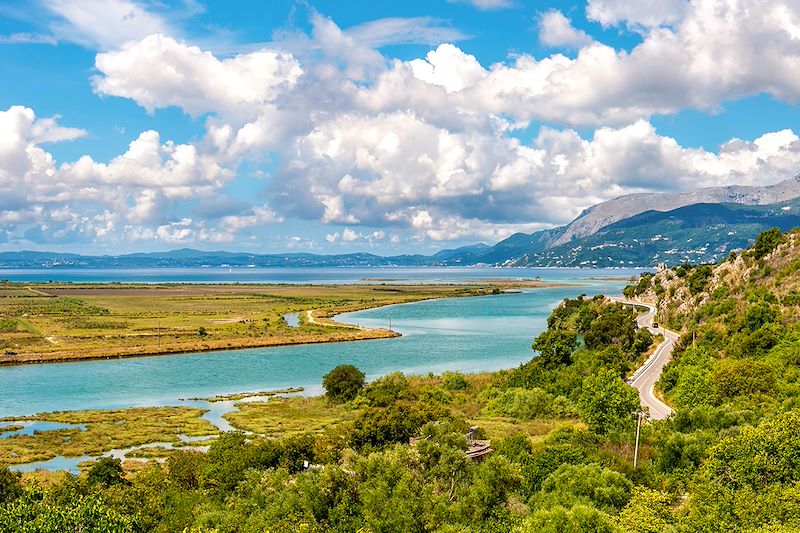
(0, 106, 238, 243)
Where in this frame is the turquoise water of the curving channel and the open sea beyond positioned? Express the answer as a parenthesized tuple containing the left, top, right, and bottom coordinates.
(0, 269, 638, 417)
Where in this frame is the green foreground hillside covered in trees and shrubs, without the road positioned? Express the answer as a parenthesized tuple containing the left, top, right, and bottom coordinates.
(0, 230, 800, 533)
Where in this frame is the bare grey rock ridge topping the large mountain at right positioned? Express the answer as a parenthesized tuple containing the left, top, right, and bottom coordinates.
(551, 175, 800, 246)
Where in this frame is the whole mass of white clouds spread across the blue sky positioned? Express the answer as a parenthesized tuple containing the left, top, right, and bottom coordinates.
(10, 0, 800, 246)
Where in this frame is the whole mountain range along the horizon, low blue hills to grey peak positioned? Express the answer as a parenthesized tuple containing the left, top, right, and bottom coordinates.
(0, 176, 800, 268)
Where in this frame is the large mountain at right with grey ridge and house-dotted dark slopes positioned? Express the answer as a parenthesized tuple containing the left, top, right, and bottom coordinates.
(454, 176, 800, 266)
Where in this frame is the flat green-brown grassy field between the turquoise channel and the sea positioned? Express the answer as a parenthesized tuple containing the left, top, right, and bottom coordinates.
(0, 281, 541, 364)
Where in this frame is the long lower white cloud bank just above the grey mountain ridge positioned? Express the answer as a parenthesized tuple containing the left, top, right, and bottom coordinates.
(272, 108, 800, 240)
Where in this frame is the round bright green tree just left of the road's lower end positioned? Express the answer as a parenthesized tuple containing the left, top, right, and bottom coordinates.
(578, 370, 639, 434)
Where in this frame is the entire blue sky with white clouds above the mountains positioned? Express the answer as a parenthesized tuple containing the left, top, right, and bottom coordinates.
(0, 0, 800, 255)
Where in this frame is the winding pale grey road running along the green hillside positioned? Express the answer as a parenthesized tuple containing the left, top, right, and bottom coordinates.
(611, 297, 679, 420)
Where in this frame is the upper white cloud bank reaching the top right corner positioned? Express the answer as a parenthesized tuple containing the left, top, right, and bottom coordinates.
(360, 0, 800, 126)
